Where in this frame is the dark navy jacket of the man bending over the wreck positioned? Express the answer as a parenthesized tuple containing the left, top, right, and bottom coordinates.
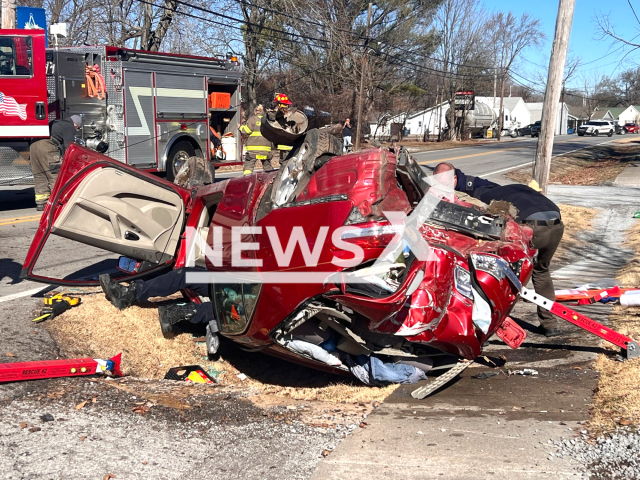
(456, 168, 560, 222)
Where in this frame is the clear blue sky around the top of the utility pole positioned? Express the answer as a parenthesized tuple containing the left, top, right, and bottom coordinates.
(499, 0, 640, 88)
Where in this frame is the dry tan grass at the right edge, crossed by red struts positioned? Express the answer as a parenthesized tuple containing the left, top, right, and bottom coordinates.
(590, 223, 640, 435)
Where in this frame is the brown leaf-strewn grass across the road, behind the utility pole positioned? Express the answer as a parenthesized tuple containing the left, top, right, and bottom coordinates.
(506, 139, 640, 185)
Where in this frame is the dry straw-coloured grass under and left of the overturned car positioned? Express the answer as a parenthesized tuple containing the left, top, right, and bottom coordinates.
(44, 291, 397, 403)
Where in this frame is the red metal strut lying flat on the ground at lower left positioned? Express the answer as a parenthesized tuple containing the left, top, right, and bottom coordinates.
(0, 353, 122, 383)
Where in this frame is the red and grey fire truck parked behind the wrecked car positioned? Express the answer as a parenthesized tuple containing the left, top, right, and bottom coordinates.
(0, 30, 242, 185)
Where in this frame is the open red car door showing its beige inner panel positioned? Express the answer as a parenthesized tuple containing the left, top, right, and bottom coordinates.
(21, 145, 191, 285)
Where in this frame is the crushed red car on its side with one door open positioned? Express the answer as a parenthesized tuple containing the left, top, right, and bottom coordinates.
(22, 130, 535, 394)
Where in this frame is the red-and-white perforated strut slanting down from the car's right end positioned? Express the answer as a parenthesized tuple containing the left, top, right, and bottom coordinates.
(520, 287, 640, 359)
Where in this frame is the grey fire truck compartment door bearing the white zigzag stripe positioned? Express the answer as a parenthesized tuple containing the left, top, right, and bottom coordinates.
(124, 70, 158, 166)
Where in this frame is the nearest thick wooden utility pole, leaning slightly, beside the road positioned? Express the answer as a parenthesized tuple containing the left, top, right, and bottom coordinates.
(533, 0, 576, 195)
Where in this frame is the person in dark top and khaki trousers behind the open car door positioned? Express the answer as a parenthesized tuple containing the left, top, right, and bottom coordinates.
(29, 115, 82, 212)
